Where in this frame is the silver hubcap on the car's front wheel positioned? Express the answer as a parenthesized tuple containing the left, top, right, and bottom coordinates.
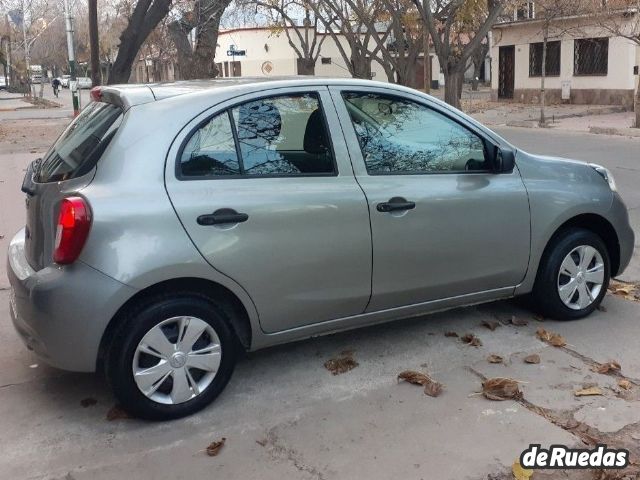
(558, 245, 604, 310)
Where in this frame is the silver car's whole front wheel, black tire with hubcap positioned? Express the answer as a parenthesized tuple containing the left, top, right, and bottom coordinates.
(531, 228, 611, 320)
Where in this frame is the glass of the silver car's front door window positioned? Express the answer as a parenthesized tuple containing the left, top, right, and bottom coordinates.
(343, 92, 490, 175)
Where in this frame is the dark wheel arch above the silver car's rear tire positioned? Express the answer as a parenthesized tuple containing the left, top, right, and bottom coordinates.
(96, 277, 253, 371)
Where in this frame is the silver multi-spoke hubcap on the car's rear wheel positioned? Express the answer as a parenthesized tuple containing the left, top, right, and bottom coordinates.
(133, 317, 222, 405)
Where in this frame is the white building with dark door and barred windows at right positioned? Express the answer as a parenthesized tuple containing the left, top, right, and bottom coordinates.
(491, 9, 640, 108)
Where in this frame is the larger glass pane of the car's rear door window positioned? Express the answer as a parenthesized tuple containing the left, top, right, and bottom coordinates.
(231, 93, 336, 176)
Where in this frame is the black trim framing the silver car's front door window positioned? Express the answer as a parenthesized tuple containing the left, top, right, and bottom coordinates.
(339, 88, 496, 177)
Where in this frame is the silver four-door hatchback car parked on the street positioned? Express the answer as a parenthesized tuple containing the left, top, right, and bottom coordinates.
(8, 78, 634, 419)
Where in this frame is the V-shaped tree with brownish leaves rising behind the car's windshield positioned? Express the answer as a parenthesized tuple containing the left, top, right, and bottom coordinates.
(413, 0, 505, 108)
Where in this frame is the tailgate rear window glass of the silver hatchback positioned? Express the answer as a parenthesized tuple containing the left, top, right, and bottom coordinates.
(35, 102, 122, 183)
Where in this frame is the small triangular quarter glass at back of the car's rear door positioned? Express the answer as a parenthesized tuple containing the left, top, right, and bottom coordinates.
(180, 112, 240, 177)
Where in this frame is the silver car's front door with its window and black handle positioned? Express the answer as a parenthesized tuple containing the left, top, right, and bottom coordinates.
(331, 87, 530, 312)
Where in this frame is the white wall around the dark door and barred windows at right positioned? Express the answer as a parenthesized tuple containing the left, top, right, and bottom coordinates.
(491, 21, 640, 107)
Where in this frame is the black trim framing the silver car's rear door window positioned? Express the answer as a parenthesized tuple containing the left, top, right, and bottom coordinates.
(174, 88, 339, 181)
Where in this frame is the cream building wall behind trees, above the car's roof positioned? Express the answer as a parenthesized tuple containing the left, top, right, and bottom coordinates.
(216, 28, 440, 87)
